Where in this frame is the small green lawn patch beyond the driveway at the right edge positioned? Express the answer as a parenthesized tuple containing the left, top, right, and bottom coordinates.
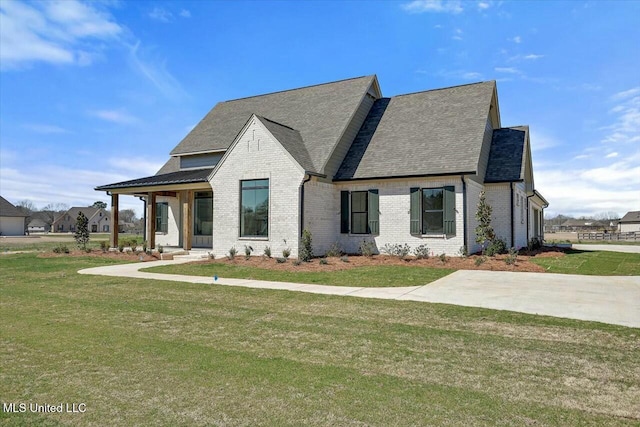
(533, 250, 640, 276)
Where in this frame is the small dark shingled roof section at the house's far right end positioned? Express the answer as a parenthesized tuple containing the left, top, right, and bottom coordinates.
(484, 127, 527, 182)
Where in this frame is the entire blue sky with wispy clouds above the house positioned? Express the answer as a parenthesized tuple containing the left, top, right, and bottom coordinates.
(0, 0, 640, 216)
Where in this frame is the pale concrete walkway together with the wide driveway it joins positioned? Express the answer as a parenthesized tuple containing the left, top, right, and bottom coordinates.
(78, 259, 640, 328)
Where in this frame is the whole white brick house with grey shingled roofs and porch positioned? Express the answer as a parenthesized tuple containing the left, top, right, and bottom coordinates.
(96, 75, 547, 257)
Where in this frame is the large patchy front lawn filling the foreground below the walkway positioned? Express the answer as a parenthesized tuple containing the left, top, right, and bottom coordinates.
(0, 254, 640, 426)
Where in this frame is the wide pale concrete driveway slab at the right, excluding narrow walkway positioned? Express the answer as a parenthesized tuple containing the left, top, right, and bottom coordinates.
(398, 270, 640, 328)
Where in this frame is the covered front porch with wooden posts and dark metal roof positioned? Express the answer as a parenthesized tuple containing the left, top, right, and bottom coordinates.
(96, 169, 213, 251)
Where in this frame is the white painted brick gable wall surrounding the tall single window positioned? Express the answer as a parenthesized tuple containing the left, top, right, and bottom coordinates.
(211, 119, 304, 257)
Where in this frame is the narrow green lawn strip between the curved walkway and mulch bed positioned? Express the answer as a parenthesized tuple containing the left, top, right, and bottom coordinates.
(143, 261, 455, 288)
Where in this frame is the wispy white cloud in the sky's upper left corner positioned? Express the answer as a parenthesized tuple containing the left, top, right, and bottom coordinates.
(0, 0, 123, 70)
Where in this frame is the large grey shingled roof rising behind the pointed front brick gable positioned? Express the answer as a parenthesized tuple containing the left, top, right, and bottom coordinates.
(169, 76, 375, 173)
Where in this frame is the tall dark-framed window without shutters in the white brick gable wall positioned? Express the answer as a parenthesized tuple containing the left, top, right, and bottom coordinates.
(240, 179, 269, 237)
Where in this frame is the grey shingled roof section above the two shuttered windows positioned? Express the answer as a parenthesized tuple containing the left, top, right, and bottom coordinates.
(334, 81, 495, 181)
